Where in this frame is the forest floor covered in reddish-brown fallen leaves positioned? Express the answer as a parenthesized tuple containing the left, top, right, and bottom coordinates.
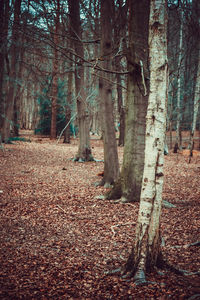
(0, 133, 200, 300)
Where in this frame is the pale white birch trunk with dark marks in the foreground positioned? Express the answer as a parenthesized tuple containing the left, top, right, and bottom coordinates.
(125, 0, 168, 284)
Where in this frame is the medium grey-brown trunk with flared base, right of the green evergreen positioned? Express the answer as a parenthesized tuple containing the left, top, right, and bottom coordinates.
(68, 0, 93, 161)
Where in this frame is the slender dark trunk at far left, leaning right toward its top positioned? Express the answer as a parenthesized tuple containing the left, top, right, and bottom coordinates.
(2, 0, 21, 142)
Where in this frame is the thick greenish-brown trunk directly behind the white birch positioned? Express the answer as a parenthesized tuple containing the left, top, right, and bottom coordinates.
(107, 0, 149, 202)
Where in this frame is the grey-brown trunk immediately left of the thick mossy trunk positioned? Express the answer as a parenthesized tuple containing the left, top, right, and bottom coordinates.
(99, 0, 119, 186)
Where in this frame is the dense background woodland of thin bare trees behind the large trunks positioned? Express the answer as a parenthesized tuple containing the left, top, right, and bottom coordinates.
(0, 0, 200, 147)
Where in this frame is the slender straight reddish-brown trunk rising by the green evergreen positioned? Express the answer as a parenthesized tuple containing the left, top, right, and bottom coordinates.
(50, 0, 60, 139)
